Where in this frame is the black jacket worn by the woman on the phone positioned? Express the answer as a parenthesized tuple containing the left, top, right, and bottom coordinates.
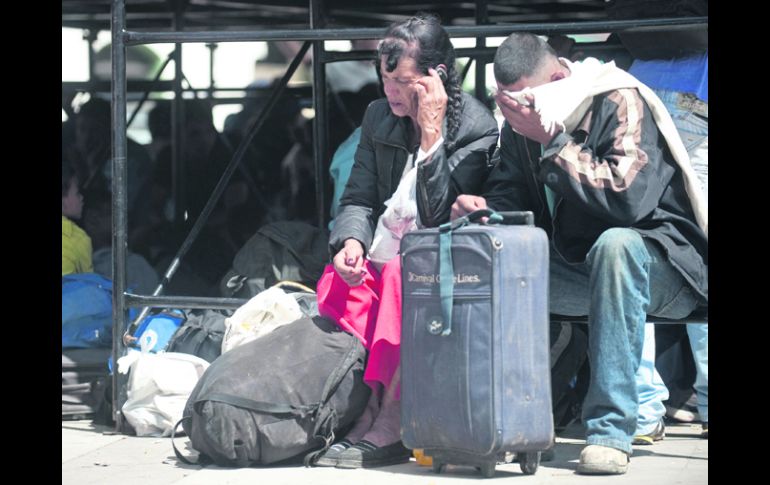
(329, 93, 498, 257)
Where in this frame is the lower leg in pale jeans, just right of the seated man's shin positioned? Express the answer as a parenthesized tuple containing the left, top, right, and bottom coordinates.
(633, 323, 668, 445)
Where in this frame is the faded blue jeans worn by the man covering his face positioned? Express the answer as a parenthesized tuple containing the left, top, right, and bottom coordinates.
(549, 228, 697, 454)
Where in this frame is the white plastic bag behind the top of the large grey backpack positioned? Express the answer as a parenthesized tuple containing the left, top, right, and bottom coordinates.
(222, 286, 303, 354)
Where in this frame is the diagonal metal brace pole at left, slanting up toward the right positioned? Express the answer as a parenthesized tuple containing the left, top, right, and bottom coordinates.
(123, 42, 310, 336)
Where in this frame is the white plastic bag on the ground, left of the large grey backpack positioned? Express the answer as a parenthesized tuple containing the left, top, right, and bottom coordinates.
(118, 337, 209, 436)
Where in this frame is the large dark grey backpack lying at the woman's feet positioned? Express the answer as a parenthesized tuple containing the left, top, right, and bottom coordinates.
(172, 317, 370, 467)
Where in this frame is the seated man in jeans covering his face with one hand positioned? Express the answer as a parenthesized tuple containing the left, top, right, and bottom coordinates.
(452, 33, 708, 474)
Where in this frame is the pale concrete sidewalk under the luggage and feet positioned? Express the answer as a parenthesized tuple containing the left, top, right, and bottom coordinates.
(62, 420, 708, 485)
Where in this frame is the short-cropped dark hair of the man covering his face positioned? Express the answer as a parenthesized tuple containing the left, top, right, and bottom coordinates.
(494, 33, 557, 84)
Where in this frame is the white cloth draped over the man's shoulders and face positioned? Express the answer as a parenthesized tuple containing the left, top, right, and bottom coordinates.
(514, 57, 708, 238)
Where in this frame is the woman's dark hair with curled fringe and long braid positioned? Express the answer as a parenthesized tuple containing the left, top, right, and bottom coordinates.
(376, 13, 462, 149)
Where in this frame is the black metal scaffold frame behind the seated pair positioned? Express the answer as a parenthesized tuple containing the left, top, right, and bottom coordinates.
(103, 0, 708, 431)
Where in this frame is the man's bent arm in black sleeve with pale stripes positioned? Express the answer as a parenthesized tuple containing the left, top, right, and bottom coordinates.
(538, 89, 676, 226)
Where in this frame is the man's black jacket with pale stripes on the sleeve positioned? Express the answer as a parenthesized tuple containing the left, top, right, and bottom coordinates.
(483, 89, 708, 302)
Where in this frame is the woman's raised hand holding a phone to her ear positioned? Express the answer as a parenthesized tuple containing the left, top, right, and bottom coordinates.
(414, 69, 448, 151)
